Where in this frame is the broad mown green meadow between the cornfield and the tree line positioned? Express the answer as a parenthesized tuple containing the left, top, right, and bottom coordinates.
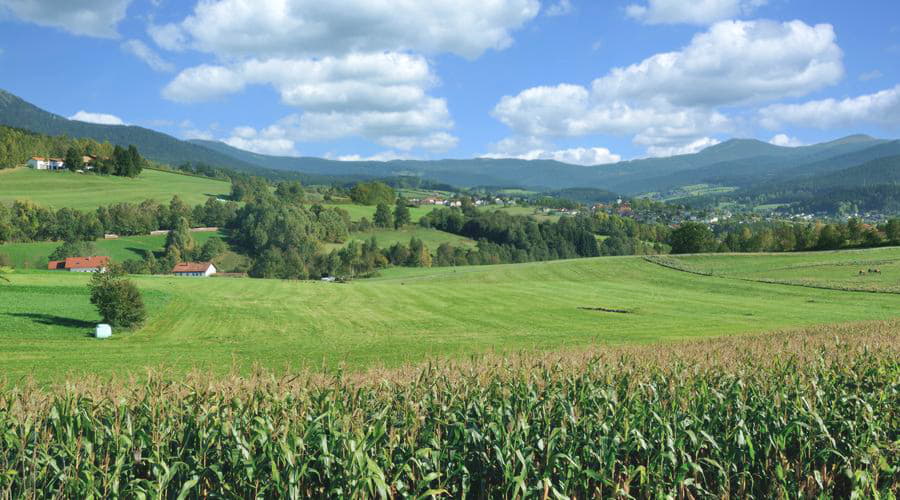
(0, 249, 900, 381)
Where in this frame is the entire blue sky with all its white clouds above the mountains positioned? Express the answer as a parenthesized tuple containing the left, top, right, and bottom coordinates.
(0, 0, 900, 164)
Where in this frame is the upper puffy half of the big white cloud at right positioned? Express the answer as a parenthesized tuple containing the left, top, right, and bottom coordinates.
(593, 21, 844, 106)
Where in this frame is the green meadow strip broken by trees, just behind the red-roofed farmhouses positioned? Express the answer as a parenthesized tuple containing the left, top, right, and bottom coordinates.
(0, 233, 224, 269)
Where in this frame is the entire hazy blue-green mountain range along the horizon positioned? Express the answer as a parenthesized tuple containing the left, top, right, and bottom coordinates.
(0, 90, 900, 199)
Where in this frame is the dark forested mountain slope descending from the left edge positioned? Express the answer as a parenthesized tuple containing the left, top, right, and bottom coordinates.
(0, 90, 259, 171)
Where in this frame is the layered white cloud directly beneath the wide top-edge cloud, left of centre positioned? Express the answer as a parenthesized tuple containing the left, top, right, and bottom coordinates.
(169, 53, 457, 151)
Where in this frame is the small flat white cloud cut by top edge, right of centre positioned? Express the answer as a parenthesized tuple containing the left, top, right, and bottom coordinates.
(625, 0, 767, 25)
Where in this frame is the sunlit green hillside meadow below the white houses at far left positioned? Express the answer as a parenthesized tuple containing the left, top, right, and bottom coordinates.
(0, 168, 231, 210)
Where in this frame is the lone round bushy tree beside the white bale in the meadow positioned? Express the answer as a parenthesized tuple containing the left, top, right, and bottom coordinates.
(88, 265, 147, 328)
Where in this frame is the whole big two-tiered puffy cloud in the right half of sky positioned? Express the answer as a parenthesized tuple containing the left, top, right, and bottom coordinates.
(492, 21, 843, 155)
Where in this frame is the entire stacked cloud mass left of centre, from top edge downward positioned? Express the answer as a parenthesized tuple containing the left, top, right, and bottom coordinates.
(149, 0, 536, 151)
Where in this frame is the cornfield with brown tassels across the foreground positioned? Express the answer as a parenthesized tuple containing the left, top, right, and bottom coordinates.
(0, 323, 900, 498)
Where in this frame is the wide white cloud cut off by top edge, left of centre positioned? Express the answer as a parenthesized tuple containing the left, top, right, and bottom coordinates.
(151, 0, 540, 58)
